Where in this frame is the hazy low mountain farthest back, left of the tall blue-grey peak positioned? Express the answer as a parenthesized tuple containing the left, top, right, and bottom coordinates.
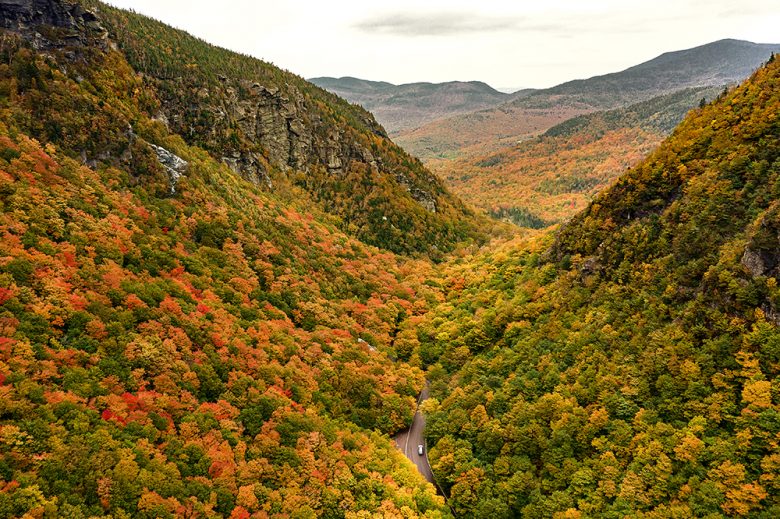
(309, 77, 512, 135)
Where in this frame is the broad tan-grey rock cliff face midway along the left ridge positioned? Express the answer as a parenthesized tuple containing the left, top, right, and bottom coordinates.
(151, 76, 386, 192)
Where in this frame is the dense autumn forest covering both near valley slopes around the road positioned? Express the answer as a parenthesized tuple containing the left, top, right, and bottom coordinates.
(0, 0, 780, 519)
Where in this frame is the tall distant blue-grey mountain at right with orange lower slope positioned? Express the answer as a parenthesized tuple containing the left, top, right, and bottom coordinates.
(395, 40, 780, 162)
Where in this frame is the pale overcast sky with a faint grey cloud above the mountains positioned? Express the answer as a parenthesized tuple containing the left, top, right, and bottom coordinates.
(109, 0, 780, 87)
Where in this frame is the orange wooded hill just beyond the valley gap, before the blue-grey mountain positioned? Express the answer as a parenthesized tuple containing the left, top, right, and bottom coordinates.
(429, 87, 723, 227)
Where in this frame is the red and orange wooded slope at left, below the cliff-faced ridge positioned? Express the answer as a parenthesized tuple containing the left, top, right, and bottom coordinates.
(0, 0, 450, 518)
